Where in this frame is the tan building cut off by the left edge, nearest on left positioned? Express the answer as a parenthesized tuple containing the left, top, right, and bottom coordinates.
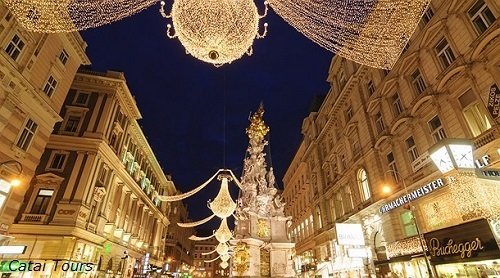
(0, 3, 89, 237)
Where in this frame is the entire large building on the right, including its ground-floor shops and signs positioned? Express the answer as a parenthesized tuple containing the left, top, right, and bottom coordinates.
(283, 0, 500, 277)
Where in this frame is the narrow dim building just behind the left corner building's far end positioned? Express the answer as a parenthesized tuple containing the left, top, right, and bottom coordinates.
(165, 199, 194, 273)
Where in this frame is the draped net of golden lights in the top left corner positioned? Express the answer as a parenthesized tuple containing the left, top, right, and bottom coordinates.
(4, 0, 156, 33)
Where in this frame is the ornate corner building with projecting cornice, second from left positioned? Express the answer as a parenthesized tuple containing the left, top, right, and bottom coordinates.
(6, 69, 176, 277)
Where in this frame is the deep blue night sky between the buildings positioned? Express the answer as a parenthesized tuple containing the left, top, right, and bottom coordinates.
(82, 4, 333, 226)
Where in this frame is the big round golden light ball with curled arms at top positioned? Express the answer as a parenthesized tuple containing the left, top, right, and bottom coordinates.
(160, 0, 267, 66)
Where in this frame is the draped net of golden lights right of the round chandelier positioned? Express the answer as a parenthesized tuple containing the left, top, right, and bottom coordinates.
(269, 0, 430, 69)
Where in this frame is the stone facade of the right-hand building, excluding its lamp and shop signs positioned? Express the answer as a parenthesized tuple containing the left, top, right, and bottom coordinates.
(283, 0, 500, 277)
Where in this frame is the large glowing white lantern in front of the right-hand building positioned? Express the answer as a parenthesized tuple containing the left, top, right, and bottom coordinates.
(429, 139, 475, 174)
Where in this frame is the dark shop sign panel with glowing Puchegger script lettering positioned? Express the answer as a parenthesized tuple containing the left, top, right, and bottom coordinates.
(424, 219, 500, 264)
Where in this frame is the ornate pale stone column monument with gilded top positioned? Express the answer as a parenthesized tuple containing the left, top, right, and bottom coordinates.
(231, 104, 295, 277)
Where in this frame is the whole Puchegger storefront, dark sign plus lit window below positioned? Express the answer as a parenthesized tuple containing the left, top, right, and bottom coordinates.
(424, 219, 500, 278)
